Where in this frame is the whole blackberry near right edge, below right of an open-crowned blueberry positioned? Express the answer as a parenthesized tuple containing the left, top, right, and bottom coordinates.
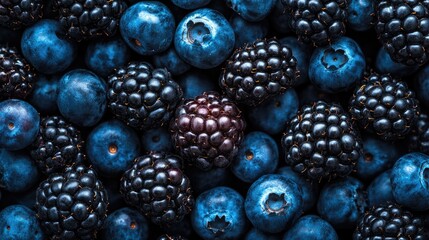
(349, 73, 419, 141)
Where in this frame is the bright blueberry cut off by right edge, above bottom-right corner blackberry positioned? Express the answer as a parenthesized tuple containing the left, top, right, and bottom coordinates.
(390, 152, 429, 211)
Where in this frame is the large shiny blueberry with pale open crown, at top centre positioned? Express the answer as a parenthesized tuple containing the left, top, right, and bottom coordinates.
(174, 8, 235, 69)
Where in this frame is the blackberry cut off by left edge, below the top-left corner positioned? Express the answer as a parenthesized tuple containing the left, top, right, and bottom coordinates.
(0, 47, 35, 101)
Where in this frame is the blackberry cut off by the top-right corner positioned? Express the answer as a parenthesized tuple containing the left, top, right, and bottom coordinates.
(375, 0, 429, 65)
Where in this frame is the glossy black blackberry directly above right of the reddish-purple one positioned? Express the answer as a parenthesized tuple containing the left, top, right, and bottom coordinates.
(219, 39, 298, 106)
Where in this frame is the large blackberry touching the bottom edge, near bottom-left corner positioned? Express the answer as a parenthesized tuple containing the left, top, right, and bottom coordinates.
(36, 165, 108, 240)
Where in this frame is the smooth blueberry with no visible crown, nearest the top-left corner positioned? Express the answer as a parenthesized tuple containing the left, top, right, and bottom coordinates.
(21, 19, 77, 74)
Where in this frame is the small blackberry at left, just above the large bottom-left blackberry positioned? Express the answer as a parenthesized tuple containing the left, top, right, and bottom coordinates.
(31, 116, 85, 174)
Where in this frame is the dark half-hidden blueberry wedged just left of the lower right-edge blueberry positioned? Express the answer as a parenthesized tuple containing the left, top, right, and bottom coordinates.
(366, 170, 395, 207)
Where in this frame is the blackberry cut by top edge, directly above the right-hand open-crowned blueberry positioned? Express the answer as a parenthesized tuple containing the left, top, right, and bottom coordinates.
(281, 0, 347, 47)
